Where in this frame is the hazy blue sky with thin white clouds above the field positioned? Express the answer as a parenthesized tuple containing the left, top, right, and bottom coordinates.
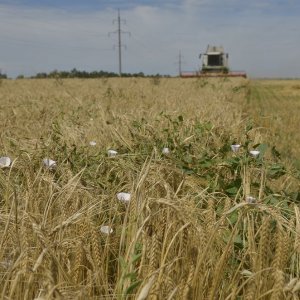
(0, 0, 300, 77)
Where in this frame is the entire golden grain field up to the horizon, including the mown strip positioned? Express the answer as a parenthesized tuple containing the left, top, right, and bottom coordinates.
(0, 78, 300, 300)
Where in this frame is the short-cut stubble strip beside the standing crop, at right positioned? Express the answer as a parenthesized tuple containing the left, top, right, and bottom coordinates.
(246, 80, 300, 167)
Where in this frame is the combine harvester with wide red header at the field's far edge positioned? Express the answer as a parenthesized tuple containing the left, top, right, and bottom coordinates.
(180, 45, 247, 78)
